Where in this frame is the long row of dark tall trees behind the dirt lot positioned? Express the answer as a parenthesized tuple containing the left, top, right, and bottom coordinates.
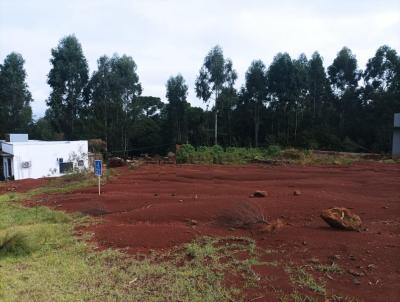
(0, 35, 400, 156)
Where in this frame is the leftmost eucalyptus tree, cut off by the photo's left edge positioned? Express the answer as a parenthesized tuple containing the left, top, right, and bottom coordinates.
(0, 52, 32, 137)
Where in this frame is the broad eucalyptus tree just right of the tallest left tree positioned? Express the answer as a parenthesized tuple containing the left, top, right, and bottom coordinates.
(86, 55, 142, 155)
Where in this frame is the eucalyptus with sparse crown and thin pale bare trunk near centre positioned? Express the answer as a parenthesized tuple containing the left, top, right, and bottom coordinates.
(195, 45, 237, 145)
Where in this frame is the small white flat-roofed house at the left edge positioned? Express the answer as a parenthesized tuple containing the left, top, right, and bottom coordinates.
(0, 134, 88, 180)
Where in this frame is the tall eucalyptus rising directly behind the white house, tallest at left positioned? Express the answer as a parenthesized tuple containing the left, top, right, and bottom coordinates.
(47, 35, 89, 139)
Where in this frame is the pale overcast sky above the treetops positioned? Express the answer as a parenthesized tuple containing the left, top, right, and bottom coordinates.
(0, 0, 400, 118)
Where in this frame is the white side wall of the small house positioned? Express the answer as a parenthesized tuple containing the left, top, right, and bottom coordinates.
(11, 141, 89, 180)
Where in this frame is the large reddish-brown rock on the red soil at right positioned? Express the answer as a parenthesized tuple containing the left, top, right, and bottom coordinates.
(321, 208, 362, 231)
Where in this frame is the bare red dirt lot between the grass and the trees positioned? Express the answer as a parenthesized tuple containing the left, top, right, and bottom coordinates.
(42, 163, 400, 302)
